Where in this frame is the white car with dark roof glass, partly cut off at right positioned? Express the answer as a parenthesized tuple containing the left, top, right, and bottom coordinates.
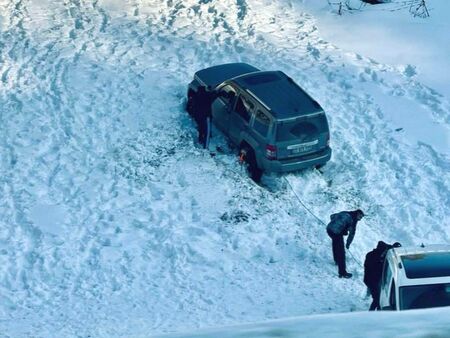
(380, 245, 450, 310)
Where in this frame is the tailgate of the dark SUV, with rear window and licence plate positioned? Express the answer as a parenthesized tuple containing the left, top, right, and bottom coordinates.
(276, 111, 329, 159)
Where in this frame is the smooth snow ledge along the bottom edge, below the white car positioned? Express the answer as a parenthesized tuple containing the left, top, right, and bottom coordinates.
(156, 308, 450, 338)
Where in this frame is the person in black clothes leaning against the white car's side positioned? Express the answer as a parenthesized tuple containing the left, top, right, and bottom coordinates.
(364, 241, 401, 311)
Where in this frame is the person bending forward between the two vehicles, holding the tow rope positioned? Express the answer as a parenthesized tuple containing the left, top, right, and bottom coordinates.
(327, 209, 364, 278)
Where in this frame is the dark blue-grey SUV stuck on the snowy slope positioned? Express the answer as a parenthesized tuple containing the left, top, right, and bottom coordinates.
(187, 63, 331, 181)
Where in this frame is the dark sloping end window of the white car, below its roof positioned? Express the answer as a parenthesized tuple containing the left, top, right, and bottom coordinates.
(400, 283, 450, 310)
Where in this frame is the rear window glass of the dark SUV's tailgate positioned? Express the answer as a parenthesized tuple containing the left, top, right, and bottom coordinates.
(277, 113, 328, 142)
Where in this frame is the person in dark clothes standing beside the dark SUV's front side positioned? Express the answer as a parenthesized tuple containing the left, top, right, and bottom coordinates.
(193, 86, 216, 148)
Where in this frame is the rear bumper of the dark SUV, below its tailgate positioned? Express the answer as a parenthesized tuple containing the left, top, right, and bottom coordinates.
(262, 147, 331, 173)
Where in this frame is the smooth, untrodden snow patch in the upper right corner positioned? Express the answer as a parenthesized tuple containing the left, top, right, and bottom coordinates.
(303, 0, 450, 98)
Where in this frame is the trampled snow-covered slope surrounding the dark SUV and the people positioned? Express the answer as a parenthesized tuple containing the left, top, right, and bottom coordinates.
(0, 0, 450, 338)
